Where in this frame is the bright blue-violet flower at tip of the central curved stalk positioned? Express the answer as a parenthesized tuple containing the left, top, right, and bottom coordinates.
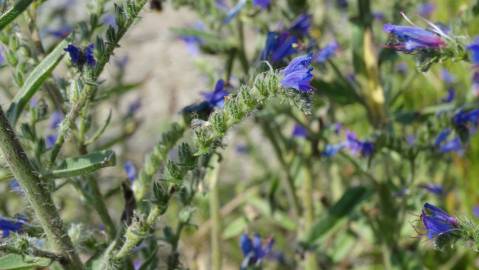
(281, 54, 313, 92)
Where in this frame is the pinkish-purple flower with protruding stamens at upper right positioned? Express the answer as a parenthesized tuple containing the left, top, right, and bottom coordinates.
(384, 24, 446, 52)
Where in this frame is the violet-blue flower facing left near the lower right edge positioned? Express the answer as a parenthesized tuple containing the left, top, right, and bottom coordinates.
(421, 203, 459, 239)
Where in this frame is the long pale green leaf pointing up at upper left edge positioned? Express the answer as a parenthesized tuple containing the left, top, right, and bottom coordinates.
(7, 39, 68, 125)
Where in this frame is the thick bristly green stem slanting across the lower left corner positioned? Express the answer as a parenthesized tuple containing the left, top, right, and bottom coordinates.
(0, 108, 83, 270)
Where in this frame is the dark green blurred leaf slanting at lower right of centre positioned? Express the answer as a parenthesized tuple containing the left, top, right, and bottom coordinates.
(306, 186, 370, 245)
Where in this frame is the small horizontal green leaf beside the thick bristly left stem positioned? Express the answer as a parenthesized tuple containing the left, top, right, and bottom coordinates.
(45, 150, 116, 179)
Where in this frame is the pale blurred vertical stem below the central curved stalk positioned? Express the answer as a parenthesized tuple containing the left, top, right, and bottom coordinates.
(206, 155, 222, 270)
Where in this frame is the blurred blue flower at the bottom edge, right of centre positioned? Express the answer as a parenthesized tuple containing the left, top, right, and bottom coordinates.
(240, 233, 274, 269)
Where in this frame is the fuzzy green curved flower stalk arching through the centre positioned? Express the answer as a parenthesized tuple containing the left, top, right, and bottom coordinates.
(103, 66, 314, 265)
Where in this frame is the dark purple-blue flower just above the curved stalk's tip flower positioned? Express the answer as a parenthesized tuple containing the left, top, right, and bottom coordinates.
(261, 32, 298, 63)
